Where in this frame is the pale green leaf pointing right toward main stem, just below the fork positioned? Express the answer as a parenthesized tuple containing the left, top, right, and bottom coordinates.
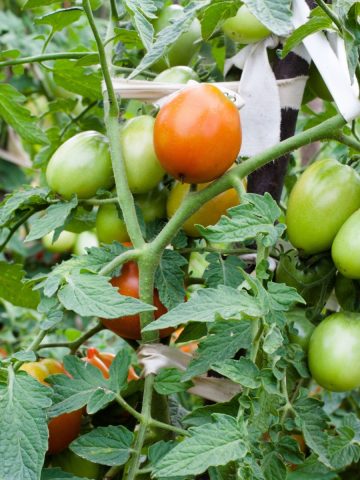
(58, 272, 154, 319)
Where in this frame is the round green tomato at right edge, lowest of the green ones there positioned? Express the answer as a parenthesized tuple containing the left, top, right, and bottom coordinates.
(308, 312, 360, 392)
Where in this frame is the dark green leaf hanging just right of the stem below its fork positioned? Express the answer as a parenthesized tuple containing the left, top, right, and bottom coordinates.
(155, 250, 187, 310)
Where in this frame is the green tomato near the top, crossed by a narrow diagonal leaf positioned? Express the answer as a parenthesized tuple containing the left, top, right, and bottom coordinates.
(152, 5, 201, 72)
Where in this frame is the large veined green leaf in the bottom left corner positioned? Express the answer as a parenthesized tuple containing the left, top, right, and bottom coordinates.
(0, 371, 51, 480)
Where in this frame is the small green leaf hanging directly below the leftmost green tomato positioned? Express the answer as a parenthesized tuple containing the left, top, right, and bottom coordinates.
(25, 198, 77, 242)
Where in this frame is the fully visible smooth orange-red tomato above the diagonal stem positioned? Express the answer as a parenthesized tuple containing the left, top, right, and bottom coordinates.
(154, 84, 242, 183)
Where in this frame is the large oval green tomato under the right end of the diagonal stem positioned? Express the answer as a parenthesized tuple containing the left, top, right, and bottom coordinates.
(286, 159, 360, 254)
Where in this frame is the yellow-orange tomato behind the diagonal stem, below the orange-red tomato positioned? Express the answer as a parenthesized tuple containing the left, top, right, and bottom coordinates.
(167, 182, 239, 237)
